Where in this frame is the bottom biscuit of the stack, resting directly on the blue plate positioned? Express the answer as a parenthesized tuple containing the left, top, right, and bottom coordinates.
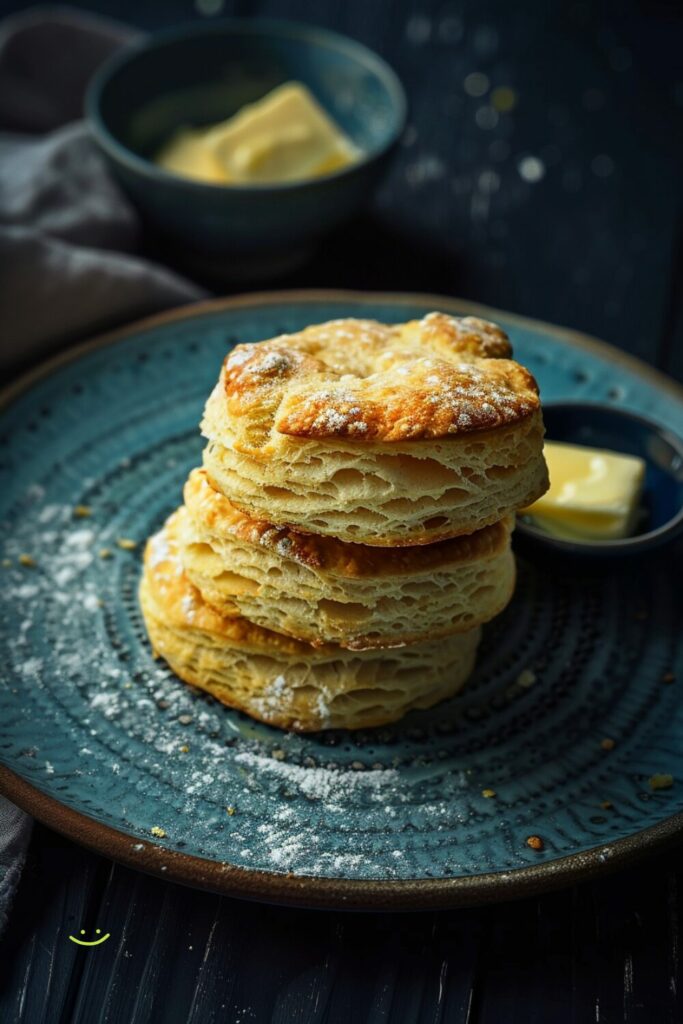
(139, 514, 479, 732)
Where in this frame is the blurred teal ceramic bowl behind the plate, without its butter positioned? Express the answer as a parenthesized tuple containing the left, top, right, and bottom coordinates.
(86, 18, 405, 280)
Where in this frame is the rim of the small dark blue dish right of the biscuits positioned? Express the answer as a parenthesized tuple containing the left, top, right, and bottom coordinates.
(516, 398, 683, 554)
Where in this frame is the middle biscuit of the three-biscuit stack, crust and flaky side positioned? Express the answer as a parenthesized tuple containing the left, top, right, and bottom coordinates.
(178, 469, 515, 650)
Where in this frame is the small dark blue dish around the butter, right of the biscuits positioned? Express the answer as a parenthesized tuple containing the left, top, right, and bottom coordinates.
(517, 402, 683, 556)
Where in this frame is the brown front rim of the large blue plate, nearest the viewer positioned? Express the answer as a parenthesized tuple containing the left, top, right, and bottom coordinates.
(0, 764, 683, 912)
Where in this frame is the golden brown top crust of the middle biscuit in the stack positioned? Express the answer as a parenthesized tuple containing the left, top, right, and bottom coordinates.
(183, 469, 513, 578)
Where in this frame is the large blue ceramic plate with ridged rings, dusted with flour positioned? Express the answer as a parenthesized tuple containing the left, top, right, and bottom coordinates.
(0, 293, 683, 908)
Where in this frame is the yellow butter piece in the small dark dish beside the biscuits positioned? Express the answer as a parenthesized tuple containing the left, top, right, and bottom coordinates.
(524, 441, 645, 541)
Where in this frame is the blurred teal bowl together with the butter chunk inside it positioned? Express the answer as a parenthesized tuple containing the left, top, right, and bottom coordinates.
(86, 18, 407, 287)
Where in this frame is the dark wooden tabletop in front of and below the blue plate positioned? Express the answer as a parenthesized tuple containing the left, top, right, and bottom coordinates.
(0, 826, 683, 1024)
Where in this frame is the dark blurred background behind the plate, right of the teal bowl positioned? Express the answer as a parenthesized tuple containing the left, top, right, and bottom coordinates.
(0, 0, 683, 377)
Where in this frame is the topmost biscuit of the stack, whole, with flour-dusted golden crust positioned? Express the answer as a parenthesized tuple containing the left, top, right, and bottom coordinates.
(202, 313, 548, 547)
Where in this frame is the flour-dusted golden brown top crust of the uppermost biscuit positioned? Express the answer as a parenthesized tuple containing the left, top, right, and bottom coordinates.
(222, 312, 540, 442)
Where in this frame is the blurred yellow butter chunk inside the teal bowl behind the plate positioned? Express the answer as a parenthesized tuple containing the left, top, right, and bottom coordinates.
(157, 82, 360, 184)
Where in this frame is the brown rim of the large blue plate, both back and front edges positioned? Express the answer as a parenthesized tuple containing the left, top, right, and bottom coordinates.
(0, 289, 683, 911)
